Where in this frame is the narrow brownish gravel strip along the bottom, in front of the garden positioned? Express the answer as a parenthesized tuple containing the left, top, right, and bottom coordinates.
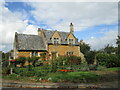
(2, 80, 119, 88)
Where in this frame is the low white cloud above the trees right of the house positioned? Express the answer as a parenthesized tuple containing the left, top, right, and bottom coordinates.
(85, 29, 118, 50)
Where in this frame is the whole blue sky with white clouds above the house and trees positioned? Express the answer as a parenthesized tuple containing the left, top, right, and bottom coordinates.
(0, 0, 118, 52)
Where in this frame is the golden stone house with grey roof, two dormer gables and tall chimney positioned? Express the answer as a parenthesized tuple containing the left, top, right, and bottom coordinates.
(14, 23, 84, 60)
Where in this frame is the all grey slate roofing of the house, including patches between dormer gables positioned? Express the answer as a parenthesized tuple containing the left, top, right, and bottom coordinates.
(16, 30, 79, 50)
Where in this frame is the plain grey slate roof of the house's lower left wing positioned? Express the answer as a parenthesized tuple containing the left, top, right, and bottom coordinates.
(16, 34, 47, 50)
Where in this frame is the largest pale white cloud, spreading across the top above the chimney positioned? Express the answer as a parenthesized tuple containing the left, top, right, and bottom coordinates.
(28, 2, 118, 31)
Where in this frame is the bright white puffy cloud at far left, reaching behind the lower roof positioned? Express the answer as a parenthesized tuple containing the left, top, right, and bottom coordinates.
(0, 2, 36, 51)
